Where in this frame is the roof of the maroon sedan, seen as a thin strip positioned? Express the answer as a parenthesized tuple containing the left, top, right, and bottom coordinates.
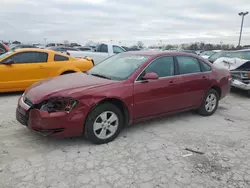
(124, 51, 199, 57)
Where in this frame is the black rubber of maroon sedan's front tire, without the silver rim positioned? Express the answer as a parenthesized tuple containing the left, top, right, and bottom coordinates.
(84, 103, 124, 144)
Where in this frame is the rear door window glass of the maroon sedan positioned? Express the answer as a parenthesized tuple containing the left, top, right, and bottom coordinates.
(176, 56, 201, 74)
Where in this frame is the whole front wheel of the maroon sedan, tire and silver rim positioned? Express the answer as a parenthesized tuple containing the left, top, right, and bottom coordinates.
(84, 102, 124, 144)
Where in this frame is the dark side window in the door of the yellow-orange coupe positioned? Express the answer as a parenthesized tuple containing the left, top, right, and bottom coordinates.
(5, 52, 48, 64)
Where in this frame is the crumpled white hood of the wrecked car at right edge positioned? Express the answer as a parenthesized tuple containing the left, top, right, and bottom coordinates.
(213, 57, 249, 70)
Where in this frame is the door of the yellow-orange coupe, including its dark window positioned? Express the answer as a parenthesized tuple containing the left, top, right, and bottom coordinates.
(0, 52, 48, 91)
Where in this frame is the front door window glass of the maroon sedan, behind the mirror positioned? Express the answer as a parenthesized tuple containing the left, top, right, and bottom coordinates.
(145, 57, 174, 77)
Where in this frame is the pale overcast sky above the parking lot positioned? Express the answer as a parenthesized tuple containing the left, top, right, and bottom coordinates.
(0, 0, 250, 45)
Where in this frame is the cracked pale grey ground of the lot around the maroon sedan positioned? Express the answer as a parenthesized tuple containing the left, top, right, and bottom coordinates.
(0, 92, 250, 188)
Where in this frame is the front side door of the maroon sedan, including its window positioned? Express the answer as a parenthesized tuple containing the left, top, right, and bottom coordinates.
(133, 56, 179, 119)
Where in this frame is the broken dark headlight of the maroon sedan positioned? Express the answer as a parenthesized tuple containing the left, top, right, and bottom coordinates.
(40, 97, 78, 113)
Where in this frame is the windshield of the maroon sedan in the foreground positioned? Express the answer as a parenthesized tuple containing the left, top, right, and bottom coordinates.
(87, 53, 150, 80)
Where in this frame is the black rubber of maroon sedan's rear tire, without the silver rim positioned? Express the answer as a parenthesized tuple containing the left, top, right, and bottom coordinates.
(199, 89, 219, 116)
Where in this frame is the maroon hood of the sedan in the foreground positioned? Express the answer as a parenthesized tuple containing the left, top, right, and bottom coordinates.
(25, 73, 115, 103)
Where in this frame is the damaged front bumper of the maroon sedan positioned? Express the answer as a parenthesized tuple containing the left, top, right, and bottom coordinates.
(16, 99, 86, 138)
